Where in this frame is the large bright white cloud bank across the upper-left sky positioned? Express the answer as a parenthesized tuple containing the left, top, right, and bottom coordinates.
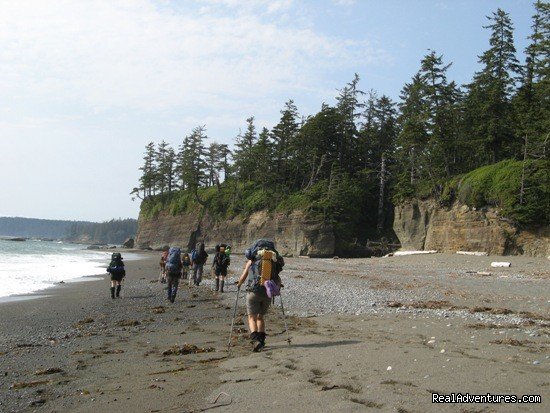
(0, 0, 385, 116)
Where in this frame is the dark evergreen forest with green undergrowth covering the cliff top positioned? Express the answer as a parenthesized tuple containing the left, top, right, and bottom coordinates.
(132, 1, 550, 245)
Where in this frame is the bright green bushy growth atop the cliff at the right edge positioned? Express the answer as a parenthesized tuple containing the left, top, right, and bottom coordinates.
(441, 160, 550, 226)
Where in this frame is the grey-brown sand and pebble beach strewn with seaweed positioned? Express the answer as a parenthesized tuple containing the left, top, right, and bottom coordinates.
(0, 249, 550, 413)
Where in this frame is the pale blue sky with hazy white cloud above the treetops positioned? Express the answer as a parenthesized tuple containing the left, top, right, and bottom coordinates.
(0, 0, 534, 221)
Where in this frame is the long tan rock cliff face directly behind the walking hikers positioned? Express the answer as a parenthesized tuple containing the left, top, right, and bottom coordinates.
(136, 211, 335, 257)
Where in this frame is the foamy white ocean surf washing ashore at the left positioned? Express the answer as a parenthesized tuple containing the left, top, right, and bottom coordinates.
(0, 239, 135, 298)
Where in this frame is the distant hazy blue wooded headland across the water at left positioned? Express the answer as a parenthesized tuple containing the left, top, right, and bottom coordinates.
(0, 217, 137, 244)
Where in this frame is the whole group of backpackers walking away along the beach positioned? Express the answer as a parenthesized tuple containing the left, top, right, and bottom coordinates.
(107, 240, 284, 351)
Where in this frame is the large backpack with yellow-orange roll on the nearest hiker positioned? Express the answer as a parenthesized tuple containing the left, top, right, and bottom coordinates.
(245, 240, 285, 295)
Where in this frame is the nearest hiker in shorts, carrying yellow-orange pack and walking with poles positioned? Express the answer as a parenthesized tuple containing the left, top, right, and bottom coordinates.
(237, 240, 285, 352)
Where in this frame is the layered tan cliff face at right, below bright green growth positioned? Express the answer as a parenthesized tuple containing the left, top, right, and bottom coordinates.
(393, 201, 550, 257)
